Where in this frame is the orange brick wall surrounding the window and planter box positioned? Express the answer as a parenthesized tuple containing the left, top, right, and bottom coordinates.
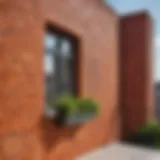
(0, 0, 119, 160)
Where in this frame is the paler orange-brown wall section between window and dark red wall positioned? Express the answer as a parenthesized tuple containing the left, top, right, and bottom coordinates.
(44, 0, 119, 160)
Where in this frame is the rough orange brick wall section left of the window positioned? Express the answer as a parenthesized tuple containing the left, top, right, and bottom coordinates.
(0, 0, 44, 135)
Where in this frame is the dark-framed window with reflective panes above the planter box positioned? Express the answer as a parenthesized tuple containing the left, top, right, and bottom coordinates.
(44, 26, 77, 109)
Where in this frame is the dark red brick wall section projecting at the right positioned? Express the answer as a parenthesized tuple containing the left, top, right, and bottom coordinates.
(120, 12, 153, 136)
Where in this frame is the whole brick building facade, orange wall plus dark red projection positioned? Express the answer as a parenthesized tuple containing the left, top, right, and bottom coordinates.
(0, 0, 153, 160)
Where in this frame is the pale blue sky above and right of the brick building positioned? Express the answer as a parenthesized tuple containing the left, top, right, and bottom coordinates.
(106, 0, 160, 81)
